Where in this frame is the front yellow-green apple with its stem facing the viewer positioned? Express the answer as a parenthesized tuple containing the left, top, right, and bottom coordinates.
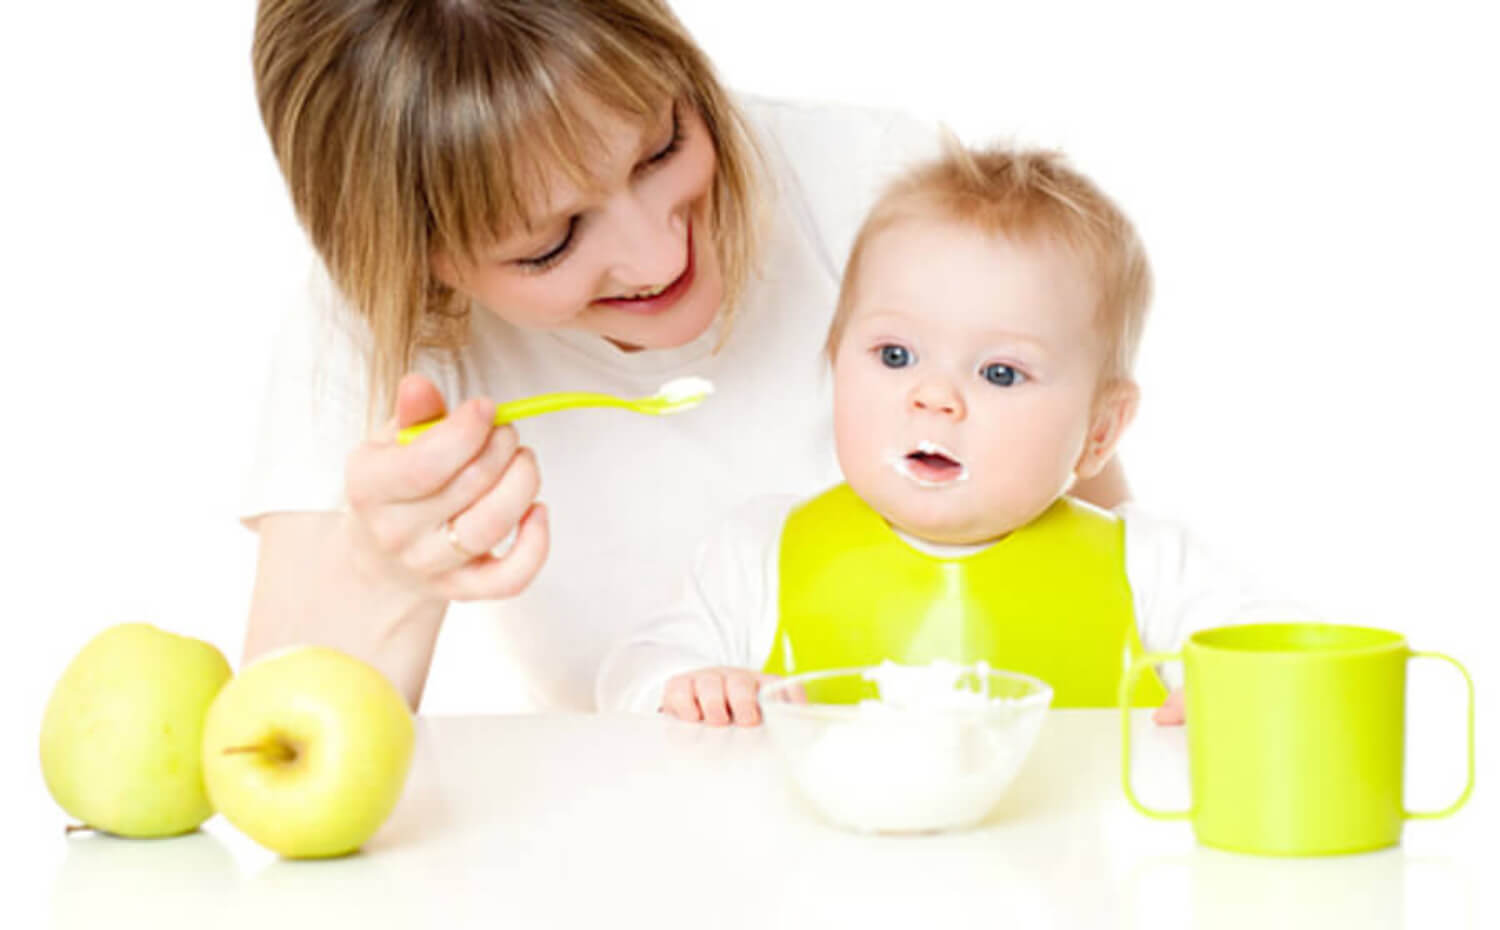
(203, 647, 416, 858)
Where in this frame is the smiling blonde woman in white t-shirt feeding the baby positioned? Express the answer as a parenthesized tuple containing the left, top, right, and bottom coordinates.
(245, 0, 1124, 710)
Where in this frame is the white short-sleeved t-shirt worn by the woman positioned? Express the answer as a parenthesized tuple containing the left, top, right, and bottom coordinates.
(242, 99, 939, 710)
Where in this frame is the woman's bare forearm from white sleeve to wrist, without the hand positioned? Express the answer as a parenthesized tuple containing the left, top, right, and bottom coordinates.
(245, 513, 447, 710)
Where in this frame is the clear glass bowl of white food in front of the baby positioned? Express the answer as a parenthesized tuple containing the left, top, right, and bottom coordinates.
(759, 662, 1052, 833)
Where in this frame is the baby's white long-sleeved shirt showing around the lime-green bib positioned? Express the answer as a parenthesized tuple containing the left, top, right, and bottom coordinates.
(597, 495, 1307, 713)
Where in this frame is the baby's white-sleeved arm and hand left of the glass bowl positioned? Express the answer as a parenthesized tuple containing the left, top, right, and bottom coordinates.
(596, 498, 795, 725)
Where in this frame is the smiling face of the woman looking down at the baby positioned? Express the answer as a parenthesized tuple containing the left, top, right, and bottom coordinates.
(434, 97, 723, 350)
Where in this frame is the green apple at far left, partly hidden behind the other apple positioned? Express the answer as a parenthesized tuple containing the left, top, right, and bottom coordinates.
(42, 623, 230, 837)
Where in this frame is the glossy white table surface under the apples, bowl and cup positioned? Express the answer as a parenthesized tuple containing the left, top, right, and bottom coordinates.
(14, 711, 1500, 930)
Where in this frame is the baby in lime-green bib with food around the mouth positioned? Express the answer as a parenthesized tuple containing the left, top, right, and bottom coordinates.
(597, 144, 1278, 725)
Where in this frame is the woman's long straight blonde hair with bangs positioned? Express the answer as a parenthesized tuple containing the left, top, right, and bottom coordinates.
(252, 0, 756, 417)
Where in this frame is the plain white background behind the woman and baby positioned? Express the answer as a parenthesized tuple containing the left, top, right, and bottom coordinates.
(0, 0, 1500, 804)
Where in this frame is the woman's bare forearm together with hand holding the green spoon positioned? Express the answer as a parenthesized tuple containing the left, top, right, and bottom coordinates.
(245, 375, 549, 710)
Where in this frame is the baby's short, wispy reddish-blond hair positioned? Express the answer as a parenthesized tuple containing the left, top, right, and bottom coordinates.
(827, 135, 1152, 384)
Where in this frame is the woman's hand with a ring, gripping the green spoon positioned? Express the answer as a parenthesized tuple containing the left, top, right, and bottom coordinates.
(344, 375, 549, 602)
